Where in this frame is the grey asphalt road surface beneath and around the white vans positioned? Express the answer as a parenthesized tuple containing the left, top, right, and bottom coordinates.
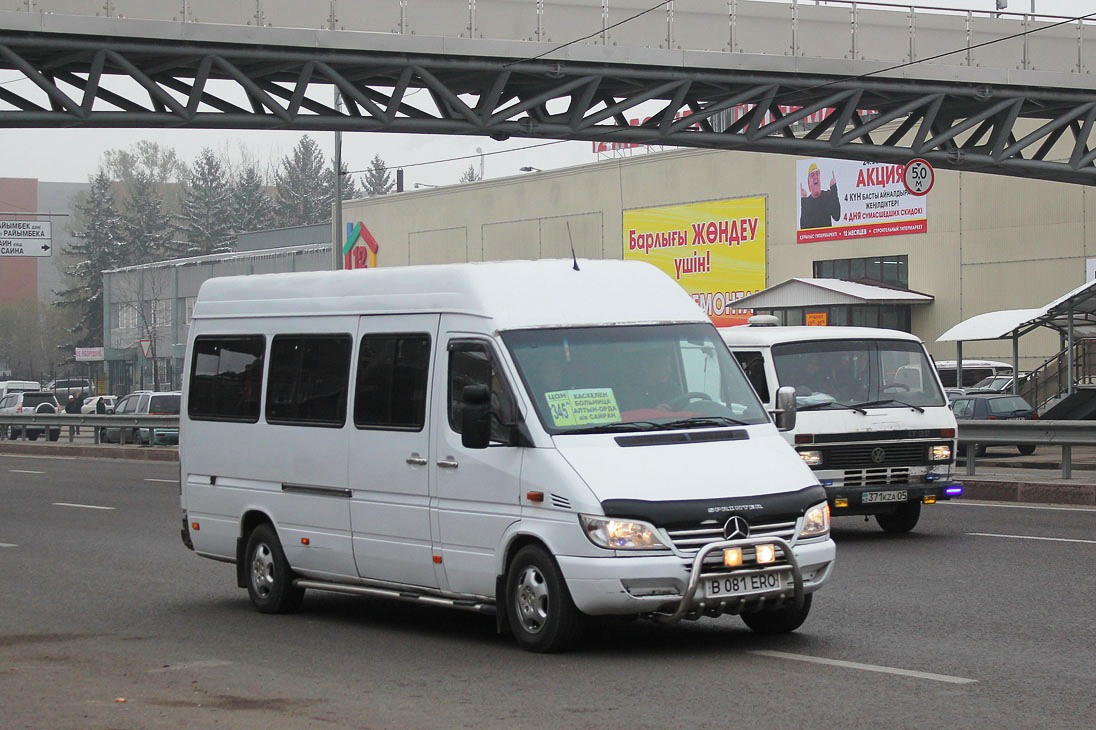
(0, 455, 1096, 730)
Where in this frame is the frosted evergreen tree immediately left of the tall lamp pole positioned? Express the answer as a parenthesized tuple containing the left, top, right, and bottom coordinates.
(275, 136, 334, 226)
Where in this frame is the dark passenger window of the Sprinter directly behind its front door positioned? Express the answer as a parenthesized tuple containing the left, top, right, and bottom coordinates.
(354, 334, 430, 431)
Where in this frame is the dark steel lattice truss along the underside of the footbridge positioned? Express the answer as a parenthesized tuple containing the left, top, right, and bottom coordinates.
(6, 31, 1096, 184)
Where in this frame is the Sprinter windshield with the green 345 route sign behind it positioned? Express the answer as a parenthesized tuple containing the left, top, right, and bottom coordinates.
(502, 323, 769, 434)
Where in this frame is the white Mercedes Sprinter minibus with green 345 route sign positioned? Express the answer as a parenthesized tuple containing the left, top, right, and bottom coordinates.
(180, 260, 835, 651)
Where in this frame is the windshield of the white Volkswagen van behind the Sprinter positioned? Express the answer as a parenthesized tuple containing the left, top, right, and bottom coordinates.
(773, 340, 947, 411)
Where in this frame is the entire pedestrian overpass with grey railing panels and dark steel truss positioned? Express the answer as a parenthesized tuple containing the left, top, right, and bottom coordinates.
(0, 0, 1096, 184)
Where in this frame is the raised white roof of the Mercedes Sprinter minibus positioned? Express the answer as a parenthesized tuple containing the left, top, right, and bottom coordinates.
(193, 259, 710, 330)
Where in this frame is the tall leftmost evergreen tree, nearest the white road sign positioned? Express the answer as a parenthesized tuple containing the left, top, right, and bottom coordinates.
(54, 170, 122, 346)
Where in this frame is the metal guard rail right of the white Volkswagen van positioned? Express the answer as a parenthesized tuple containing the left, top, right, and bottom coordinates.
(958, 420, 1096, 479)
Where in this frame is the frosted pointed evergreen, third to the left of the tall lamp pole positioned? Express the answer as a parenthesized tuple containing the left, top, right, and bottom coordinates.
(180, 147, 236, 255)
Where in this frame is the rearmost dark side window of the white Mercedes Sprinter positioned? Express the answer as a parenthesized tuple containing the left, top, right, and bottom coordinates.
(186, 335, 266, 423)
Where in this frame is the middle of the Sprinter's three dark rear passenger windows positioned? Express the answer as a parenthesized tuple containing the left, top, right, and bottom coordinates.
(266, 334, 353, 426)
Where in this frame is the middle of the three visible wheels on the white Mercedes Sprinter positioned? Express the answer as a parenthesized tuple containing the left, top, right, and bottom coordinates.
(505, 545, 585, 652)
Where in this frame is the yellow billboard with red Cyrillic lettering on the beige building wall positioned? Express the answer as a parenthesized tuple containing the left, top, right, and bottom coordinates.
(624, 197, 765, 327)
